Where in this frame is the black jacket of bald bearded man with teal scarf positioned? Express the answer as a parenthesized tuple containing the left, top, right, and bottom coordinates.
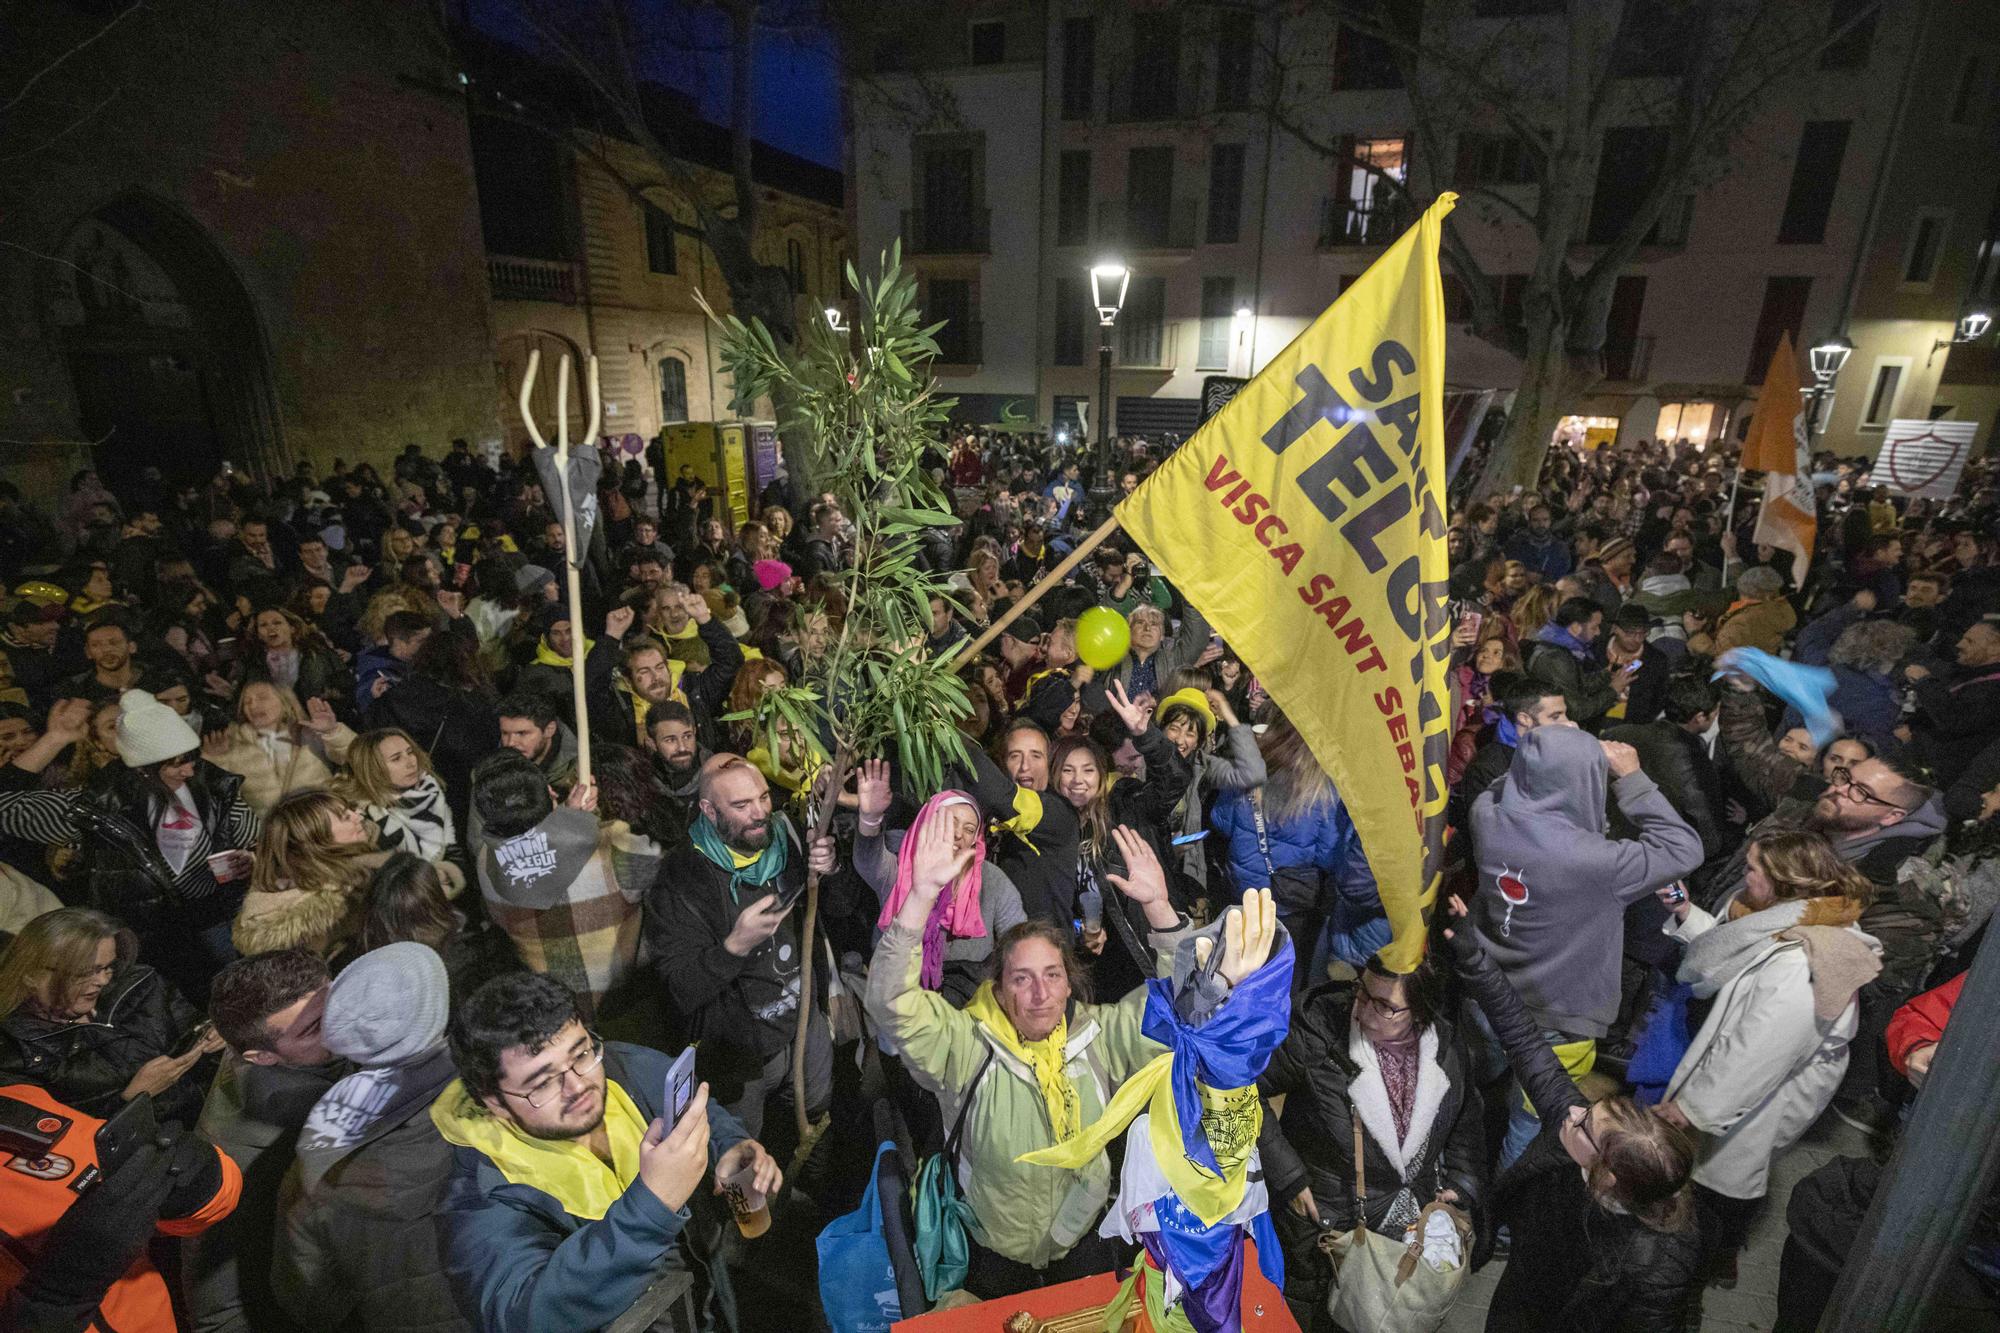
(644, 815, 824, 1101)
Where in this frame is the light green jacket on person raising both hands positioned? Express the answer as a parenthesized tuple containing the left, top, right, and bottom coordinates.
(868, 923, 1186, 1267)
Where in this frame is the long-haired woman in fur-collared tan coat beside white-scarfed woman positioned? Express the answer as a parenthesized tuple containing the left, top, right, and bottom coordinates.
(230, 791, 388, 955)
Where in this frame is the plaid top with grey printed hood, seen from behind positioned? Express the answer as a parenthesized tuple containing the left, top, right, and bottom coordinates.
(476, 807, 644, 1021)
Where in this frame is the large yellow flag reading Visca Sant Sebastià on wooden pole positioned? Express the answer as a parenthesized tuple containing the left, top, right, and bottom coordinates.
(1118, 194, 1456, 971)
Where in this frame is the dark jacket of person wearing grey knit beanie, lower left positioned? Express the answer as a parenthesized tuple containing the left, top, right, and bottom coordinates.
(272, 1047, 474, 1333)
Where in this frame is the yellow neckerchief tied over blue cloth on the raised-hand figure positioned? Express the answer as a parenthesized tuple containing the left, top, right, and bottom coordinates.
(1016, 1053, 1264, 1227)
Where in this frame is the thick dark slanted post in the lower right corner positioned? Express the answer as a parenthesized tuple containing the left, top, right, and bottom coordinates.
(1820, 931, 2000, 1333)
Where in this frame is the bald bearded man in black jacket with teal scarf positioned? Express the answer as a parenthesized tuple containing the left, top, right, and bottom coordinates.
(644, 755, 834, 1135)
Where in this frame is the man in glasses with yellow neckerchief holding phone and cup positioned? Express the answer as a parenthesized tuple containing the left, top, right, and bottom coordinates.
(430, 973, 782, 1333)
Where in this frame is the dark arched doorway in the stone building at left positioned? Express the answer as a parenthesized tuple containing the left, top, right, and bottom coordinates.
(50, 194, 290, 490)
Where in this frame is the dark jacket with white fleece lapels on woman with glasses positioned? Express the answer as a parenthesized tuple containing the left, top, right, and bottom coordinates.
(1258, 981, 1486, 1239)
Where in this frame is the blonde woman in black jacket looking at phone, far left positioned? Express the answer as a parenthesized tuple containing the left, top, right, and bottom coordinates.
(0, 907, 222, 1125)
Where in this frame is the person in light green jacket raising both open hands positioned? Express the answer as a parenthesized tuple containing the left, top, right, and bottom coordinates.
(866, 819, 1188, 1299)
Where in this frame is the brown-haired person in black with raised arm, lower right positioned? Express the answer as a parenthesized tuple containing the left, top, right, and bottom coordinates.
(1444, 897, 1702, 1333)
